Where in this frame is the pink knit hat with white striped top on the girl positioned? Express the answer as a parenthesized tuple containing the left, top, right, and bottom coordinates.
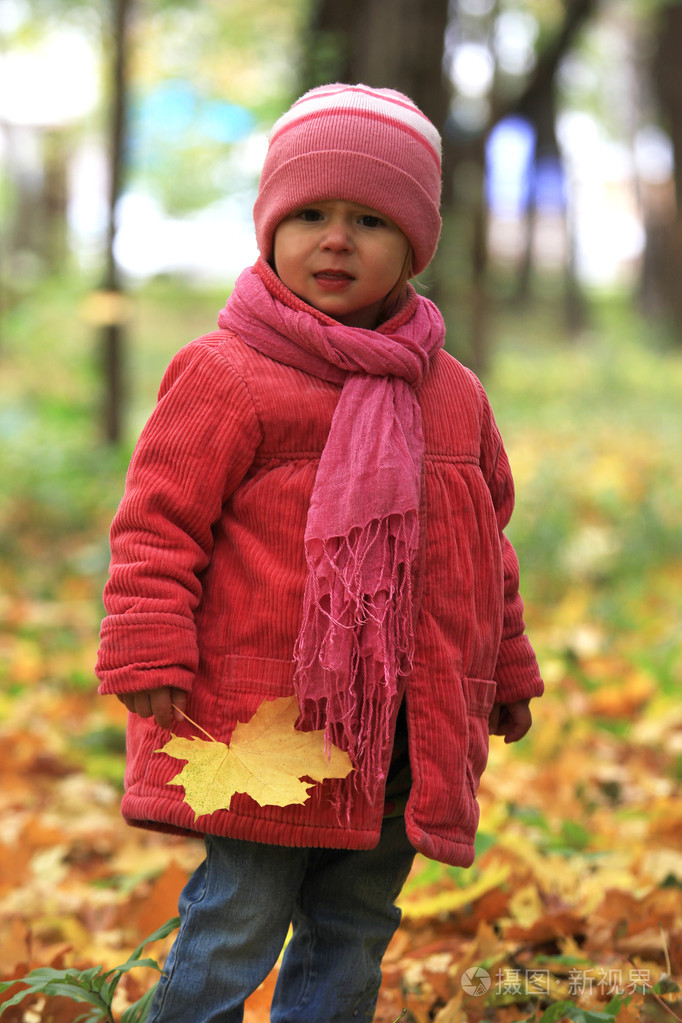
(254, 84, 441, 274)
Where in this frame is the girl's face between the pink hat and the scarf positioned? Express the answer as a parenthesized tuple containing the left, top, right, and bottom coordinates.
(273, 199, 410, 328)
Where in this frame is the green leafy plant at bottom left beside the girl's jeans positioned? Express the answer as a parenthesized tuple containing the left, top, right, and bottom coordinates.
(0, 917, 180, 1023)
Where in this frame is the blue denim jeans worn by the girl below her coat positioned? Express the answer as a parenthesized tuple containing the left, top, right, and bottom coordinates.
(147, 817, 414, 1023)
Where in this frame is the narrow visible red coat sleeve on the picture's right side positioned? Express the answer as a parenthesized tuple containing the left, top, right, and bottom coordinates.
(474, 388, 544, 703)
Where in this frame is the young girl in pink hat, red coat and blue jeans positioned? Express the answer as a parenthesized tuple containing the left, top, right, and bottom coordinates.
(97, 85, 542, 1023)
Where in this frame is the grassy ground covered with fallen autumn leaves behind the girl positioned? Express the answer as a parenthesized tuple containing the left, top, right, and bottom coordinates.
(0, 285, 682, 1023)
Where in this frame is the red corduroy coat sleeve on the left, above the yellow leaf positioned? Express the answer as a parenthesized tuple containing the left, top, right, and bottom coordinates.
(95, 339, 261, 694)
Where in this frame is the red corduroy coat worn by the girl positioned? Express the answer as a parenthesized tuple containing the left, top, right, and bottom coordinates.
(96, 330, 542, 865)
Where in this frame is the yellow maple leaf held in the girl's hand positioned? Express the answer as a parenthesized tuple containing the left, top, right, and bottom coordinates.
(154, 697, 353, 819)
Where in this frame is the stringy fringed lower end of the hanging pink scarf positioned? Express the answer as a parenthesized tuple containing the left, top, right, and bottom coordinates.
(294, 510, 419, 806)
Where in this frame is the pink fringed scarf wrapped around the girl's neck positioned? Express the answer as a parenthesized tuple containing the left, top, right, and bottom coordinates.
(219, 260, 445, 791)
